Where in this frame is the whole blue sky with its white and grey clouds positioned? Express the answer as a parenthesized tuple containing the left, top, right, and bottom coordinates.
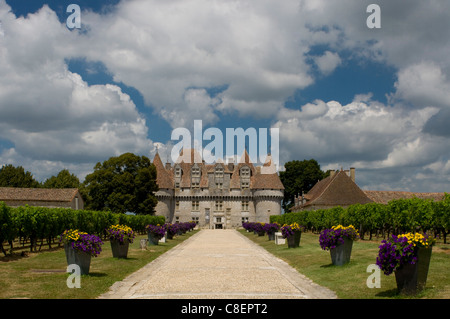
(0, 0, 450, 192)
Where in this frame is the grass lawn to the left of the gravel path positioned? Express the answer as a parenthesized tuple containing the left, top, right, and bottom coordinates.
(0, 231, 197, 299)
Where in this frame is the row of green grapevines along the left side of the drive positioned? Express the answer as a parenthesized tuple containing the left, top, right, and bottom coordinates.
(0, 202, 165, 255)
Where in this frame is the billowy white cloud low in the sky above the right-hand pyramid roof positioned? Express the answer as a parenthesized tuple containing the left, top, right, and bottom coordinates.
(275, 96, 442, 167)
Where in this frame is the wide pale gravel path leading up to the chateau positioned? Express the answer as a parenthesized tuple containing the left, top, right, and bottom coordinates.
(99, 229, 336, 299)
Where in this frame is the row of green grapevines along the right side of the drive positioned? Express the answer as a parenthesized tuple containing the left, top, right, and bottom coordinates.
(270, 193, 450, 243)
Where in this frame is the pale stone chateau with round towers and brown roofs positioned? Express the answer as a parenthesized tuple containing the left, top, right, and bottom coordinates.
(153, 149, 284, 229)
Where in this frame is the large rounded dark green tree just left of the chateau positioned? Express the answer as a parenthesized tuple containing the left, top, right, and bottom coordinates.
(82, 153, 158, 214)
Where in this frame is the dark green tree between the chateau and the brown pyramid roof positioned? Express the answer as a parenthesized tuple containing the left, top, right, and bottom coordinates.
(280, 159, 328, 212)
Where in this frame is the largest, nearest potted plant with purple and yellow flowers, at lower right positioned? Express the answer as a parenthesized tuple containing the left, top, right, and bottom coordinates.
(377, 233, 436, 295)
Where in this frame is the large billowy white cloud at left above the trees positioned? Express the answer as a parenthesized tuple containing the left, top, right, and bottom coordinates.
(0, 1, 155, 176)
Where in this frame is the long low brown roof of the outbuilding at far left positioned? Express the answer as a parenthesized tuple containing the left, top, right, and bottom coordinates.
(0, 187, 78, 202)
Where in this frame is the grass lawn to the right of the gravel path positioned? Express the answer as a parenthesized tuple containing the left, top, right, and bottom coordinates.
(241, 230, 450, 299)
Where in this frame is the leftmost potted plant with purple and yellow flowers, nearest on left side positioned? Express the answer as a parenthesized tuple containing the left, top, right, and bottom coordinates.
(60, 229, 103, 275)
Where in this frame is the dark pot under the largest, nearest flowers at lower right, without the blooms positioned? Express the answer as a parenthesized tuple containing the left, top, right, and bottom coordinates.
(395, 247, 432, 295)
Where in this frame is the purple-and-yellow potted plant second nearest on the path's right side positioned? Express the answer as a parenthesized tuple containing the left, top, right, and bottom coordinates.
(319, 225, 359, 266)
